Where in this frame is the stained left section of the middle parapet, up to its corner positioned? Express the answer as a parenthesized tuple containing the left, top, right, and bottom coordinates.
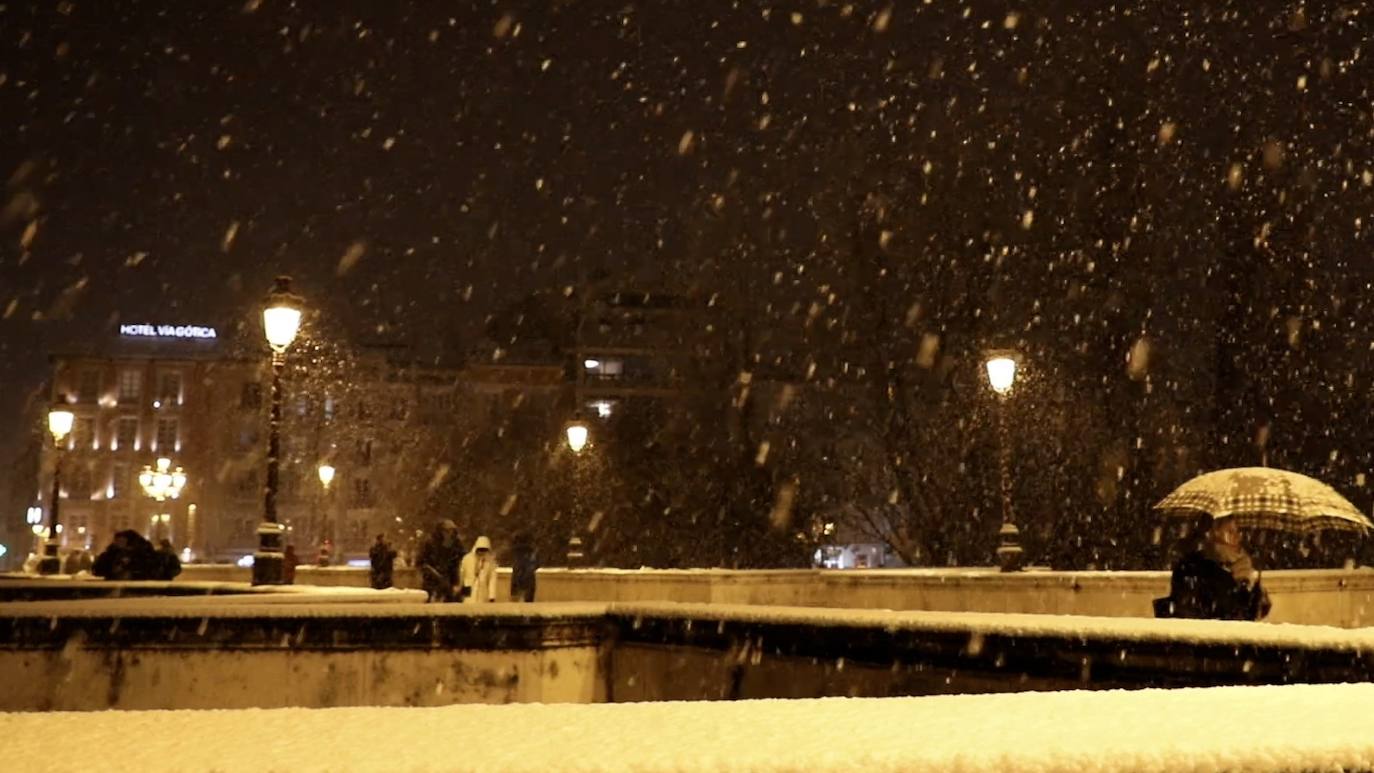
(0, 612, 609, 711)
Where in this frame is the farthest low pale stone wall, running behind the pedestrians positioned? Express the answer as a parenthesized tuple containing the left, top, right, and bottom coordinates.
(179, 564, 1374, 627)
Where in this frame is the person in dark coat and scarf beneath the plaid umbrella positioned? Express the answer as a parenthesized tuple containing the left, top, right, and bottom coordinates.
(1154, 518, 1270, 621)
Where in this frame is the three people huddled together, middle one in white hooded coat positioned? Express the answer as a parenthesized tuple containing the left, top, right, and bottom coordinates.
(412, 520, 539, 604)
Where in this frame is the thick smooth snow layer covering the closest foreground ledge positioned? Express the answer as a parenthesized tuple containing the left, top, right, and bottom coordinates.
(0, 684, 1374, 773)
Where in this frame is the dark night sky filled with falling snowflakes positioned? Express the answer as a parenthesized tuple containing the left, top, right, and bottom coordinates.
(0, 0, 1374, 527)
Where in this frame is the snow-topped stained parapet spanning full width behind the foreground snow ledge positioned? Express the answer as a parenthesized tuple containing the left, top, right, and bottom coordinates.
(0, 598, 1374, 710)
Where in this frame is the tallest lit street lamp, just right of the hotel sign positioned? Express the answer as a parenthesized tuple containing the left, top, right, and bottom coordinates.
(253, 276, 304, 585)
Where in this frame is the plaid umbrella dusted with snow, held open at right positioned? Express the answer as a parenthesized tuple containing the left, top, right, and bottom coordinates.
(1154, 467, 1374, 533)
